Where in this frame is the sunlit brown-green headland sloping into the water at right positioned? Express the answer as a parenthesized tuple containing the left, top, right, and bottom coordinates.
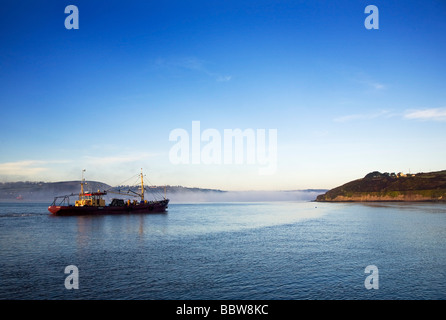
(316, 170, 446, 202)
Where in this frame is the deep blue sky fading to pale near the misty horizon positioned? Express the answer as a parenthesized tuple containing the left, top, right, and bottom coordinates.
(0, 0, 446, 190)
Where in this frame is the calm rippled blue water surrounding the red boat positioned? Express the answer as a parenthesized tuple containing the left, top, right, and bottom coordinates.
(0, 202, 446, 300)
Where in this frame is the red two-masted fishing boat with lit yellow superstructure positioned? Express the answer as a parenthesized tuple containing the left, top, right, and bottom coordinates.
(48, 170, 169, 216)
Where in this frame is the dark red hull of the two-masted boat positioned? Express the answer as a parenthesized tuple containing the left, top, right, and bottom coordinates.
(48, 199, 169, 216)
